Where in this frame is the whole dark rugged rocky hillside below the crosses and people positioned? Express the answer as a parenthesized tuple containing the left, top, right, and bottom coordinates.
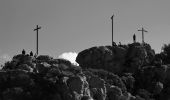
(0, 43, 170, 100)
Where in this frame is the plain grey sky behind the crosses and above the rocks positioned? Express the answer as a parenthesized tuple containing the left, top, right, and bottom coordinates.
(0, 0, 170, 63)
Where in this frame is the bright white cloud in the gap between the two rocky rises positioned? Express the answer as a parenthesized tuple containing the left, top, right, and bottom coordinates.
(58, 52, 78, 65)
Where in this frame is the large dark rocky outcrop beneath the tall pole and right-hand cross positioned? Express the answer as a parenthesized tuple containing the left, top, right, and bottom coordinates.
(76, 43, 155, 74)
